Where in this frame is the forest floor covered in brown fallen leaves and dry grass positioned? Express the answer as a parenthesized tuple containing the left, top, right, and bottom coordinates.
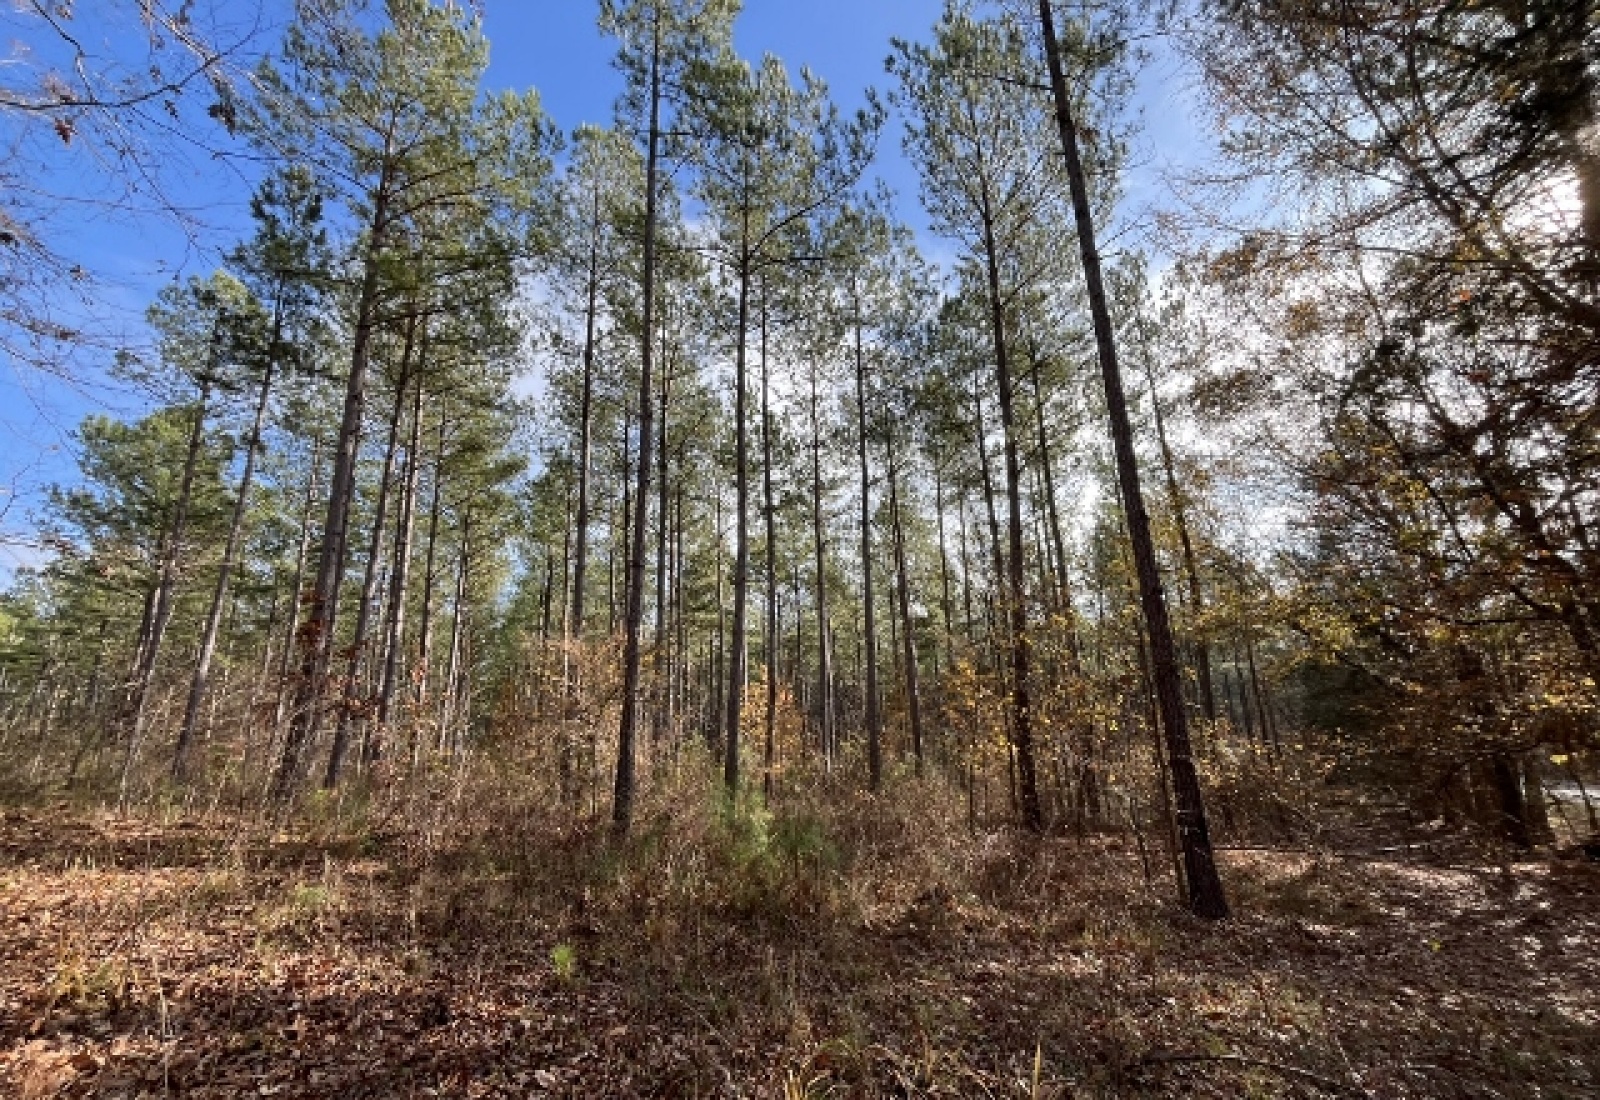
(0, 777, 1600, 1100)
